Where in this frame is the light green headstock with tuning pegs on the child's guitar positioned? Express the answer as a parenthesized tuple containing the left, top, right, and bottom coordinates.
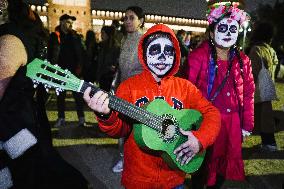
(26, 58, 81, 93)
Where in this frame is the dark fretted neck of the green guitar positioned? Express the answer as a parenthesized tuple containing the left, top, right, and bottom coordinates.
(80, 81, 162, 132)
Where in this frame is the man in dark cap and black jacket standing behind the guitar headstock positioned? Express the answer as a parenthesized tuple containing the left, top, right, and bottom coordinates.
(48, 14, 85, 127)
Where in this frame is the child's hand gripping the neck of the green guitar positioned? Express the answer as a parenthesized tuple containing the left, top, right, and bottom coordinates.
(84, 87, 110, 115)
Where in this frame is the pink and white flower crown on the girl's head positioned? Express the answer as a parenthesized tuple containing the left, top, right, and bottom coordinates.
(207, 3, 250, 26)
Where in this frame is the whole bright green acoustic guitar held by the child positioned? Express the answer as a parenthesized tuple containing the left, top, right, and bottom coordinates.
(26, 59, 205, 173)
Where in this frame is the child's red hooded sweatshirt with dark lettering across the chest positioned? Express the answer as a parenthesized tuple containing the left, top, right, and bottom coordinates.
(97, 24, 220, 189)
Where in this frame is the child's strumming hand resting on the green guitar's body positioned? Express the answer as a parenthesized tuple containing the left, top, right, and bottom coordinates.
(174, 128, 202, 165)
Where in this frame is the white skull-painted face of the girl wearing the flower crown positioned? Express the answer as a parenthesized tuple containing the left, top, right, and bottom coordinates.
(214, 18, 239, 48)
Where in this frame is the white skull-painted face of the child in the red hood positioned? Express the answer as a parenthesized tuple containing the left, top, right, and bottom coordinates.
(146, 37, 175, 77)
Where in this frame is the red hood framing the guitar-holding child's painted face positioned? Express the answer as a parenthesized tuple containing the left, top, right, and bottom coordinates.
(138, 24, 180, 75)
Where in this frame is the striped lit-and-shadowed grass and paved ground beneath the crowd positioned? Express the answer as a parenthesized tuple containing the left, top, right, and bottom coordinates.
(47, 92, 284, 189)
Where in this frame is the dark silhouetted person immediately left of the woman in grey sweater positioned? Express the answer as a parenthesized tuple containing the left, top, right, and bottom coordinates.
(95, 26, 120, 91)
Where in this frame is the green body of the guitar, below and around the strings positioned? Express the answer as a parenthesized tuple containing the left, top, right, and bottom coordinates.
(133, 99, 205, 173)
